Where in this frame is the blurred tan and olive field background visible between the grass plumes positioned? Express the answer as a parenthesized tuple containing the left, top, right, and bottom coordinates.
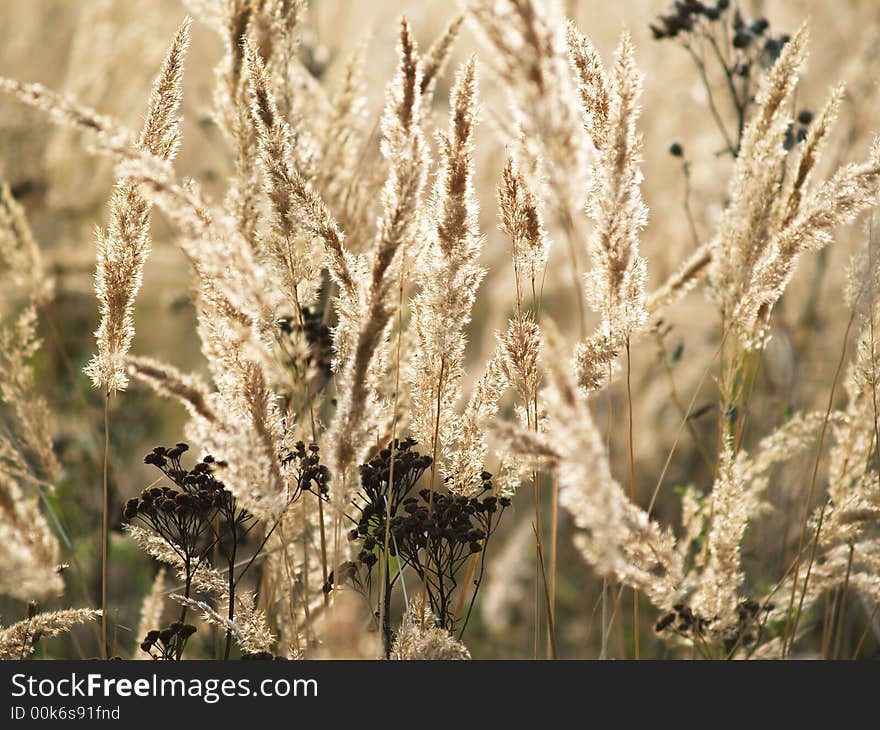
(0, 0, 880, 659)
